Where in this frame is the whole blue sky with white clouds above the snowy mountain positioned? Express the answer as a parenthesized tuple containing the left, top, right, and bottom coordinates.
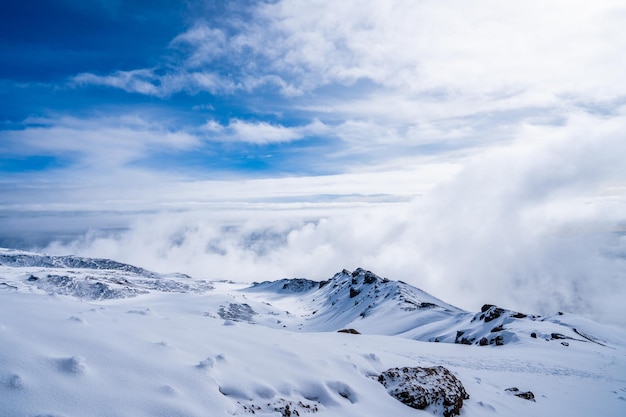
(0, 0, 626, 326)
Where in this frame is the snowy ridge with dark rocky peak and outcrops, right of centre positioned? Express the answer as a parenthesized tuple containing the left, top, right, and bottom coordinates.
(242, 268, 616, 352)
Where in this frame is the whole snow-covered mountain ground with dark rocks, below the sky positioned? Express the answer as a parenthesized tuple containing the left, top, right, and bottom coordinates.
(0, 249, 626, 417)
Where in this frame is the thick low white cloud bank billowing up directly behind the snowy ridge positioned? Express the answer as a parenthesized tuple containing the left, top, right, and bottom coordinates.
(41, 113, 626, 325)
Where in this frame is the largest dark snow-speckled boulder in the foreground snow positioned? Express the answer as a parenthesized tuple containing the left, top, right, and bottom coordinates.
(378, 366, 469, 417)
